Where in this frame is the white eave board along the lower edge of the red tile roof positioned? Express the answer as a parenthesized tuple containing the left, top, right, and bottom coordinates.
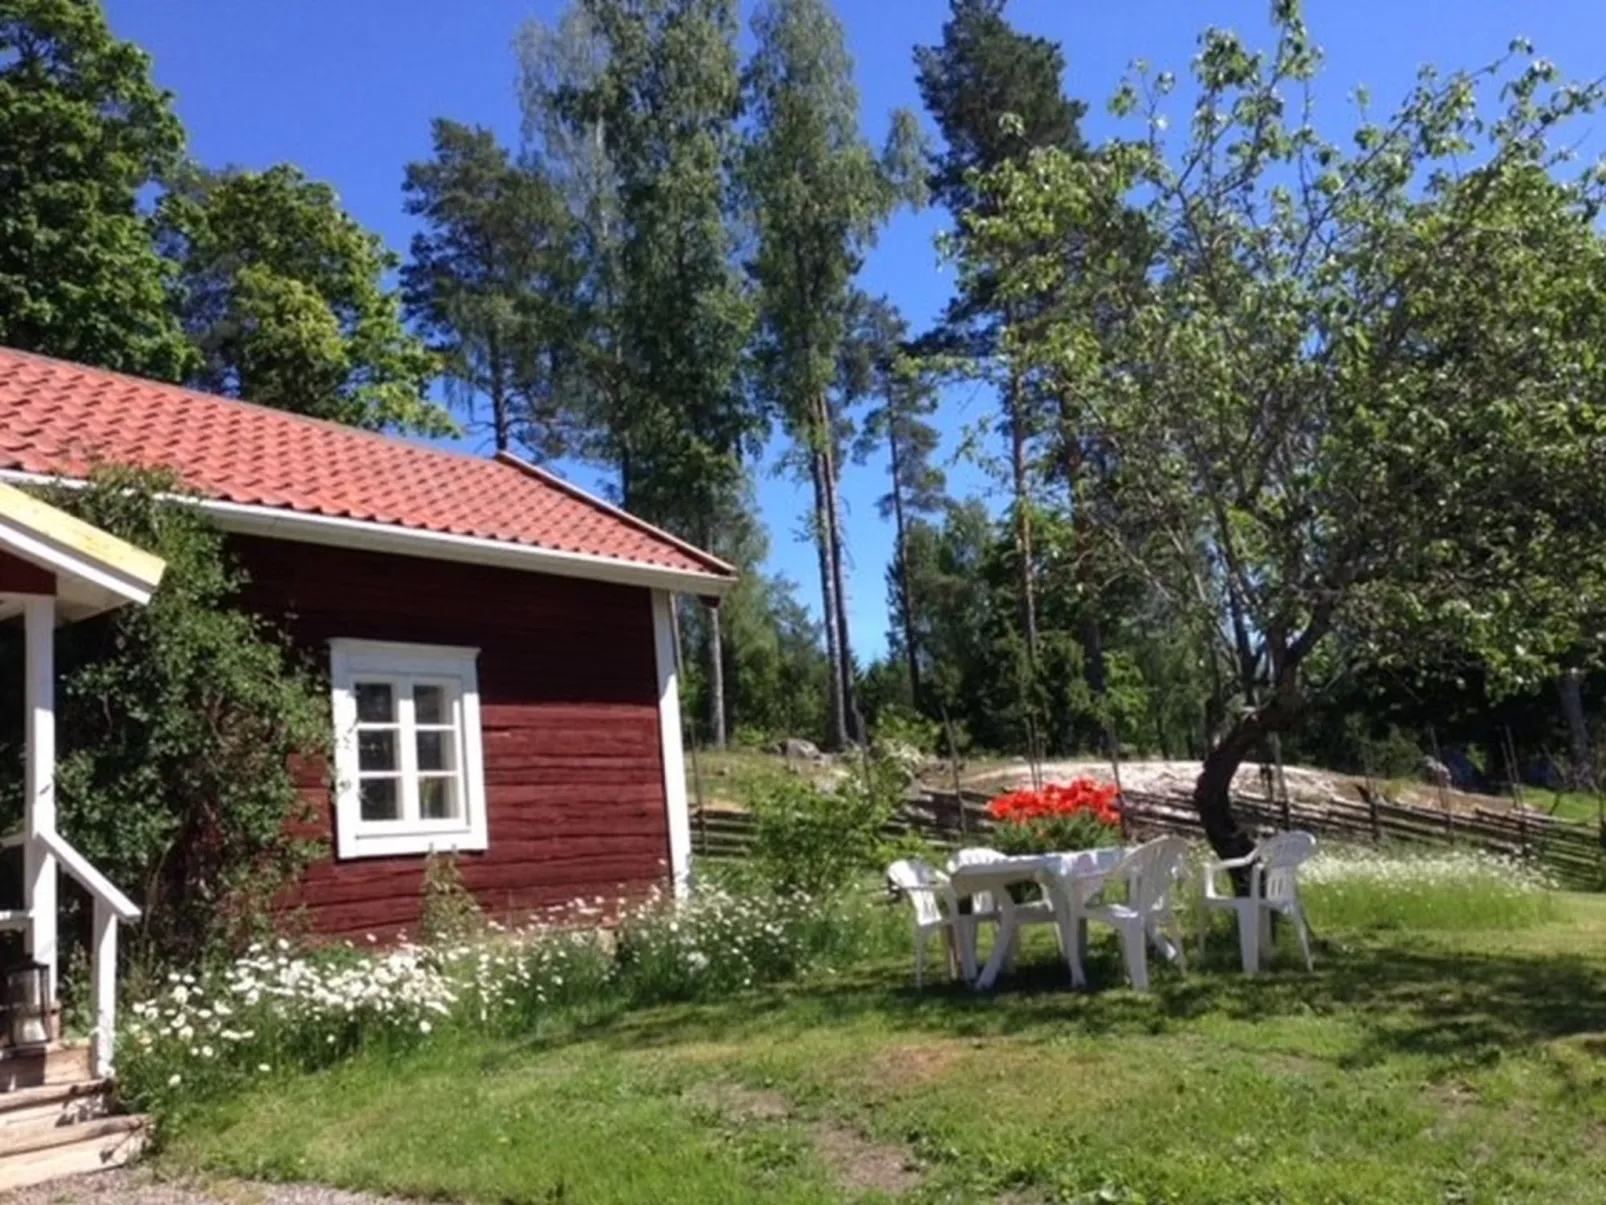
(0, 469, 736, 598)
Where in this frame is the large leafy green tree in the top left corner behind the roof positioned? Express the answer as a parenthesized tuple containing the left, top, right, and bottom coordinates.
(0, 0, 193, 381)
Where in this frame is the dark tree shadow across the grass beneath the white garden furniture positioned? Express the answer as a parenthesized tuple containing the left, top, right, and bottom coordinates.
(535, 940, 1606, 1067)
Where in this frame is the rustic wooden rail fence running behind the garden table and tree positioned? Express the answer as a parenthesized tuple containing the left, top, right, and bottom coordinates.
(692, 790, 1606, 887)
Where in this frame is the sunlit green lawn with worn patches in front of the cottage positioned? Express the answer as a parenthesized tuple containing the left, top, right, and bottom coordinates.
(161, 895, 1606, 1205)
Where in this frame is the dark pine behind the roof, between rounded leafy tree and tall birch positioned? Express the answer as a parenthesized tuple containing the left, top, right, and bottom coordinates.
(402, 121, 583, 460)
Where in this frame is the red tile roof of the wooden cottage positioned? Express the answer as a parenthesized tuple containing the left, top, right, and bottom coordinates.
(0, 347, 732, 588)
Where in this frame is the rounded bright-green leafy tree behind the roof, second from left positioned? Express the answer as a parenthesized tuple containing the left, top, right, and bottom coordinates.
(156, 164, 453, 435)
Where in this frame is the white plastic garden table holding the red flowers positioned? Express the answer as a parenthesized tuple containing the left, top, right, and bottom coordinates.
(949, 845, 1129, 991)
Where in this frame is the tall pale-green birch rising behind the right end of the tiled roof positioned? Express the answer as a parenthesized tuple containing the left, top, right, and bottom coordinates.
(520, 0, 761, 543)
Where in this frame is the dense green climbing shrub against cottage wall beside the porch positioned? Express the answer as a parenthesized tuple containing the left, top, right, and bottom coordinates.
(0, 471, 332, 961)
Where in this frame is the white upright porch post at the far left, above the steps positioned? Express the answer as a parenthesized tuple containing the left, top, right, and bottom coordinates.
(22, 594, 56, 1004)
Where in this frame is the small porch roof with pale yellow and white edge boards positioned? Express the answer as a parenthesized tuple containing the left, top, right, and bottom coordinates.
(0, 482, 165, 622)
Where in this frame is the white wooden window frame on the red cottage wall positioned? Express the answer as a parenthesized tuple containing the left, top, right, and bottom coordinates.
(329, 638, 490, 858)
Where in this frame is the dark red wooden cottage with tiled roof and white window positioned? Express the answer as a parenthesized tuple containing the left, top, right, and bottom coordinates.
(0, 349, 736, 937)
